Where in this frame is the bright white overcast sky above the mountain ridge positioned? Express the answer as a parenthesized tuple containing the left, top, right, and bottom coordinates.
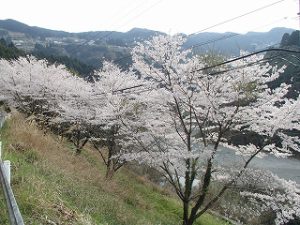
(0, 0, 299, 34)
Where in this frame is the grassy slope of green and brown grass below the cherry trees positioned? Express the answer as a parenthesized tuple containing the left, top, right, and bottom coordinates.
(0, 115, 226, 225)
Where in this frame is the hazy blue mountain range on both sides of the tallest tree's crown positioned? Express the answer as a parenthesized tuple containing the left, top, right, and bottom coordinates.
(0, 19, 294, 68)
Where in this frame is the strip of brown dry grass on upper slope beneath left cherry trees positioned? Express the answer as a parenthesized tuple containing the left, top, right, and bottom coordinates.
(9, 113, 103, 181)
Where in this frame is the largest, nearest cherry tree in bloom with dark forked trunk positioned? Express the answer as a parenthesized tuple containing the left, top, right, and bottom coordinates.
(125, 36, 300, 225)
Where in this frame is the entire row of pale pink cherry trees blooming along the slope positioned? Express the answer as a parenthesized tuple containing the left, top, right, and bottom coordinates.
(0, 36, 300, 225)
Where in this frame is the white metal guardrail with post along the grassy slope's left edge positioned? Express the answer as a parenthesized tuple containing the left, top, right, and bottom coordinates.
(0, 112, 24, 225)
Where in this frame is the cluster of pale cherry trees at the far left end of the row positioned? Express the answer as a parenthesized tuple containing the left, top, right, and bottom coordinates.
(0, 56, 91, 151)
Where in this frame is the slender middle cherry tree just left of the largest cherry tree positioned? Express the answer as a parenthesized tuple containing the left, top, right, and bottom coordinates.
(93, 62, 141, 179)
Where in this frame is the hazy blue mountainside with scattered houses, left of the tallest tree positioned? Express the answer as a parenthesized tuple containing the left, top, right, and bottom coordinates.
(0, 19, 161, 68)
